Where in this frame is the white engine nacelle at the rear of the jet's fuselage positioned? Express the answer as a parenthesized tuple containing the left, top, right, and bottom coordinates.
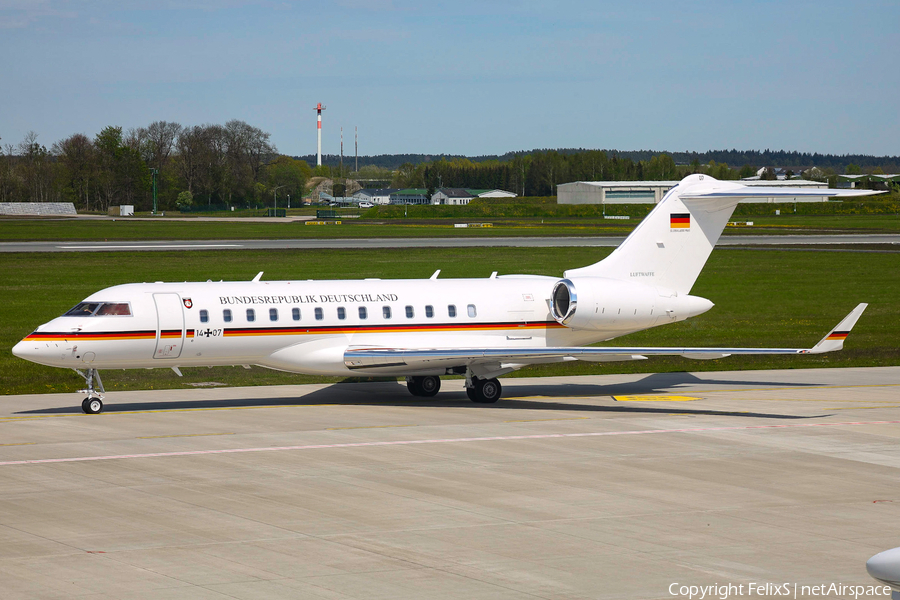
(550, 277, 713, 330)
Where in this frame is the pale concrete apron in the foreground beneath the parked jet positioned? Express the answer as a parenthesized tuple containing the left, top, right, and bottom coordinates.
(0, 367, 900, 600)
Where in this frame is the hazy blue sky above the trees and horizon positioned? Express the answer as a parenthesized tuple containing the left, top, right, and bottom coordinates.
(0, 0, 900, 155)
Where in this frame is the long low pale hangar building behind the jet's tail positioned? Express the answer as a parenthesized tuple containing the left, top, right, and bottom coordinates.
(556, 179, 828, 204)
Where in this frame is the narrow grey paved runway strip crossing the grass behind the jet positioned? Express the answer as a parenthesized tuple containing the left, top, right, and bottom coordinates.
(0, 234, 900, 252)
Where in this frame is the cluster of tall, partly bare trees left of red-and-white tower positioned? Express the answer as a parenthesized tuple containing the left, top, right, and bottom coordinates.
(0, 120, 313, 211)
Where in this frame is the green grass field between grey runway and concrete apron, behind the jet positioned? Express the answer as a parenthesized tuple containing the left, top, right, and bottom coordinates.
(0, 248, 900, 394)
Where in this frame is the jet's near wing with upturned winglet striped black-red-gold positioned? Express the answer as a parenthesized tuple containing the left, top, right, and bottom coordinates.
(344, 303, 868, 374)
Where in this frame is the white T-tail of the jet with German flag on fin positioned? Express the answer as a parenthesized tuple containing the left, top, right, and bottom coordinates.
(565, 175, 873, 294)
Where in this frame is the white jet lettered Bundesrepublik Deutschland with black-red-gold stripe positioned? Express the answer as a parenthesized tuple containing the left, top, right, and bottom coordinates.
(13, 175, 871, 414)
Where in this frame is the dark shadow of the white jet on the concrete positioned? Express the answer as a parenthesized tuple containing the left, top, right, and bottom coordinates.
(17, 373, 825, 419)
